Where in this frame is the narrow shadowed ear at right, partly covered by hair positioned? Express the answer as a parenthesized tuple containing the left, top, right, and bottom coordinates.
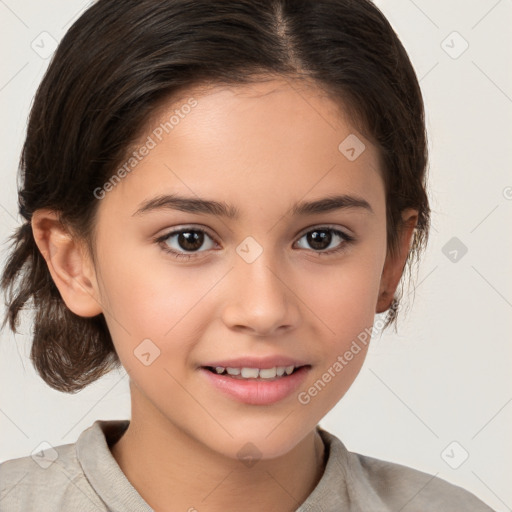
(375, 208, 418, 313)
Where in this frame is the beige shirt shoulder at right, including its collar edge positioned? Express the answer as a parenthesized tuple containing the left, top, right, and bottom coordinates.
(323, 431, 493, 512)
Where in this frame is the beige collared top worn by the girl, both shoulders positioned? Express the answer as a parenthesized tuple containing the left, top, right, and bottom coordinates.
(0, 420, 493, 512)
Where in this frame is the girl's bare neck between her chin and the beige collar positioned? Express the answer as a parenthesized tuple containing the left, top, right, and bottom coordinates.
(110, 386, 324, 512)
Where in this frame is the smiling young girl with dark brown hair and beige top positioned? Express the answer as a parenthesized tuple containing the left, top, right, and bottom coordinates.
(0, 0, 491, 512)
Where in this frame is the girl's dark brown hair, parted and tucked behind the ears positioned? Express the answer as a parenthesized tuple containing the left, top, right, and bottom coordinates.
(1, 0, 430, 393)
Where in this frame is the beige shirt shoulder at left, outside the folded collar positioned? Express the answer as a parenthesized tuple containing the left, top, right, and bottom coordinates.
(0, 443, 106, 512)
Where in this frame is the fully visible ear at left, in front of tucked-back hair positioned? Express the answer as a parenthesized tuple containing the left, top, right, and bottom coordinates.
(31, 209, 103, 317)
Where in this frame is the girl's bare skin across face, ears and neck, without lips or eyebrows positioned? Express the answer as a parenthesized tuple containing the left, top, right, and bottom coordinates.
(32, 79, 418, 512)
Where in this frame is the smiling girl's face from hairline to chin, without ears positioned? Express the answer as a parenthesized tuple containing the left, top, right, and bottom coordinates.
(88, 81, 386, 458)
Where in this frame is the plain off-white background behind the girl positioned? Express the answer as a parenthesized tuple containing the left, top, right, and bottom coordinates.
(0, 0, 512, 511)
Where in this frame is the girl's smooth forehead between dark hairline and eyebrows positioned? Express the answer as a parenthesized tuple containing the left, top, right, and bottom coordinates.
(97, 79, 383, 220)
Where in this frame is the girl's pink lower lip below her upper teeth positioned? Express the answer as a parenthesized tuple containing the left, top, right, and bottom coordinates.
(200, 366, 311, 405)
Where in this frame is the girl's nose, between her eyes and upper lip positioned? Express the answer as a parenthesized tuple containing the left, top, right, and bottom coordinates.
(222, 251, 301, 337)
